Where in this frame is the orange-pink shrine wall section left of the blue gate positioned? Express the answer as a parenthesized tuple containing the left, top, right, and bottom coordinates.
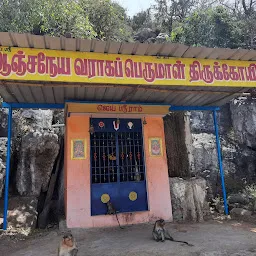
(65, 115, 90, 224)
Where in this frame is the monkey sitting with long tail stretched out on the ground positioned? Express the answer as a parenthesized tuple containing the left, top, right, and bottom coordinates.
(152, 219, 193, 246)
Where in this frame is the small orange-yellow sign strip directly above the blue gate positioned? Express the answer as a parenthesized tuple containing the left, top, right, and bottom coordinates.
(67, 103, 170, 115)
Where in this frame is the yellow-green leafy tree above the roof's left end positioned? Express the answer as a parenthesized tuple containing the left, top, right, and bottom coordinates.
(0, 0, 95, 38)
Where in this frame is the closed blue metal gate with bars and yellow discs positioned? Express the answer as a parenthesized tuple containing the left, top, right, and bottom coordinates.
(90, 118, 148, 215)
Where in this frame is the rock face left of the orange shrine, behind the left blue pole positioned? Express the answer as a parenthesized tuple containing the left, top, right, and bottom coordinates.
(0, 109, 64, 229)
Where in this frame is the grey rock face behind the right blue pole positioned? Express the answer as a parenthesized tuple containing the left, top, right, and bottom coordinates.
(190, 98, 256, 212)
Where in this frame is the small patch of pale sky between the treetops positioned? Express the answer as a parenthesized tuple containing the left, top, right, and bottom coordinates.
(115, 0, 154, 16)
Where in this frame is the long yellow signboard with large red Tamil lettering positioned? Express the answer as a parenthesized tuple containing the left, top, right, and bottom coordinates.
(0, 47, 256, 87)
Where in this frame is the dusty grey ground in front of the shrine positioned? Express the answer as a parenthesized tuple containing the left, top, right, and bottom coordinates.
(0, 221, 256, 256)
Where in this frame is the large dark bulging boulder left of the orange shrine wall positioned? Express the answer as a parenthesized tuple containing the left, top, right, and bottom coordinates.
(16, 131, 59, 196)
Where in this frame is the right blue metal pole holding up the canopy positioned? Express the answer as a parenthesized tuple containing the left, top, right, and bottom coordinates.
(213, 110, 228, 215)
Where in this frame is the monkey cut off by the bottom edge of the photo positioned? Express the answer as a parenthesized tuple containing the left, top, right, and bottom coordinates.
(58, 234, 78, 256)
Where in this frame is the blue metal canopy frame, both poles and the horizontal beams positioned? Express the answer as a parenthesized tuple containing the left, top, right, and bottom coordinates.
(0, 102, 228, 230)
